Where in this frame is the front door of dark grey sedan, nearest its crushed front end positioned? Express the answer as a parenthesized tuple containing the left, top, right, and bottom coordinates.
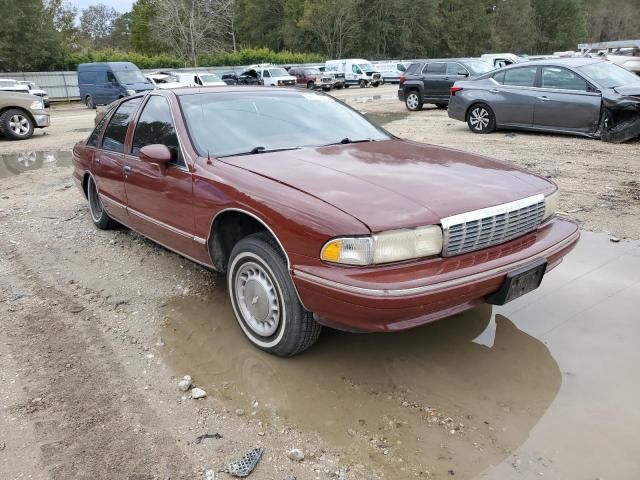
(533, 65, 602, 133)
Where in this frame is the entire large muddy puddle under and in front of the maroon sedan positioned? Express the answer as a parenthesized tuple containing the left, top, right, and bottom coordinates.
(162, 232, 640, 479)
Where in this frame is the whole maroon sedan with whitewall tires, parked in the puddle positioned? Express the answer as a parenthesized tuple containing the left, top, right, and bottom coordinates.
(73, 87, 579, 356)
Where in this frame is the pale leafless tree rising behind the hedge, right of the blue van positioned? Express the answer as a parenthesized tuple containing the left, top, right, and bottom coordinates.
(152, 0, 235, 66)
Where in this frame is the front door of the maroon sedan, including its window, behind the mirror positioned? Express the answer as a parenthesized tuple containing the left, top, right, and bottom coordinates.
(125, 95, 202, 257)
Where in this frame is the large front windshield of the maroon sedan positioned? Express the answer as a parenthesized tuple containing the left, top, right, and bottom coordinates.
(180, 92, 391, 157)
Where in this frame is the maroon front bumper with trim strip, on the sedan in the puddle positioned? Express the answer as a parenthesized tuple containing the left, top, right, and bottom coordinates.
(293, 219, 580, 332)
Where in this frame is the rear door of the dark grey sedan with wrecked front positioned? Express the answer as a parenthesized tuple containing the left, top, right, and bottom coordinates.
(489, 65, 539, 127)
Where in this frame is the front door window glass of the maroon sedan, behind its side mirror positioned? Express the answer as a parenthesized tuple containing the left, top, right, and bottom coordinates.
(131, 95, 182, 164)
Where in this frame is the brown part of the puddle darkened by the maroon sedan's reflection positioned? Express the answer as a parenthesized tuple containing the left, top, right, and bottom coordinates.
(162, 286, 561, 479)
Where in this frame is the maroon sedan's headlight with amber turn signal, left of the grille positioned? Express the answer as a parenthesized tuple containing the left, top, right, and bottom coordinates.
(320, 225, 442, 265)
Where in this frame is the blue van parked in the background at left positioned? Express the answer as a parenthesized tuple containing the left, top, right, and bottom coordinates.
(78, 62, 155, 109)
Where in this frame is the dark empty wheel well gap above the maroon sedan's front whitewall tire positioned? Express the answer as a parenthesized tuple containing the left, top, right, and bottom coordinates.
(208, 210, 272, 272)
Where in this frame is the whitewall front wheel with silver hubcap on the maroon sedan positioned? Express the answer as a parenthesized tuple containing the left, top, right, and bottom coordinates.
(227, 232, 322, 357)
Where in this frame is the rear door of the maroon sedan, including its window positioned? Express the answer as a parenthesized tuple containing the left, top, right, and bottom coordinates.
(93, 97, 142, 224)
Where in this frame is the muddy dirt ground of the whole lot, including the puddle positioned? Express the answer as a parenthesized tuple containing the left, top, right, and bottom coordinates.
(0, 86, 640, 480)
